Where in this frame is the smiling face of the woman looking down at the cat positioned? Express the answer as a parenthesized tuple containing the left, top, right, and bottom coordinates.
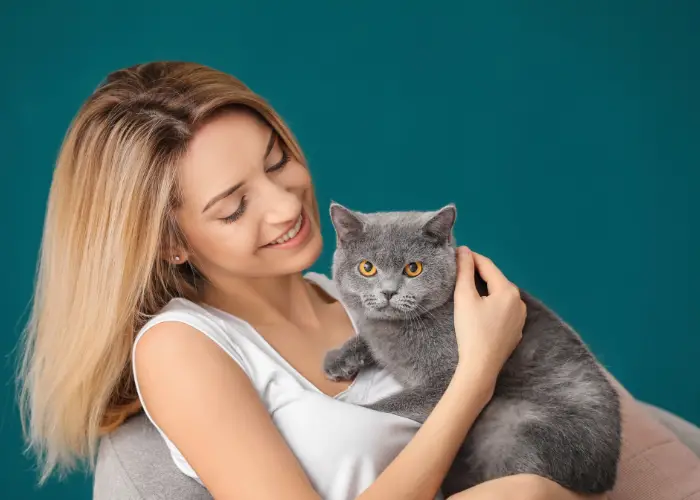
(177, 111, 322, 282)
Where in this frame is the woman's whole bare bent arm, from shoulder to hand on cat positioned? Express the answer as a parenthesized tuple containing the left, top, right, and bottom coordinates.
(136, 248, 525, 500)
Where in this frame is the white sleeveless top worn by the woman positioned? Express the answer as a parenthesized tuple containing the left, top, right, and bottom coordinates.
(132, 273, 443, 500)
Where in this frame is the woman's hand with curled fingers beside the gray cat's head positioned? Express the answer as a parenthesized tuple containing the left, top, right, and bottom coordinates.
(454, 247, 527, 384)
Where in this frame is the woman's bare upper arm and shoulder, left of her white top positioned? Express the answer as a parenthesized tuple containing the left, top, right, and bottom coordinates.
(134, 321, 319, 500)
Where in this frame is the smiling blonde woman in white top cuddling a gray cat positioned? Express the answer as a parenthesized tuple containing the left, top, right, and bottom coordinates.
(16, 62, 608, 500)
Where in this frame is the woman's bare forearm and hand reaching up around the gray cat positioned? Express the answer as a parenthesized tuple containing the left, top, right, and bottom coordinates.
(358, 249, 525, 500)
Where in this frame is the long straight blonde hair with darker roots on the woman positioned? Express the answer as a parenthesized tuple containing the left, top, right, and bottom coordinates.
(18, 62, 306, 483)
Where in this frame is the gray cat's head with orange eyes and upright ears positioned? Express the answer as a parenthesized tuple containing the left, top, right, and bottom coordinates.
(330, 203, 457, 320)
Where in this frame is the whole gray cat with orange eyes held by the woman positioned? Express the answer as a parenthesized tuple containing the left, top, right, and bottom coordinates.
(324, 203, 621, 495)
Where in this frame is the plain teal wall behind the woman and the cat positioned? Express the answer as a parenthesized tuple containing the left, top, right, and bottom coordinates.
(0, 0, 700, 499)
